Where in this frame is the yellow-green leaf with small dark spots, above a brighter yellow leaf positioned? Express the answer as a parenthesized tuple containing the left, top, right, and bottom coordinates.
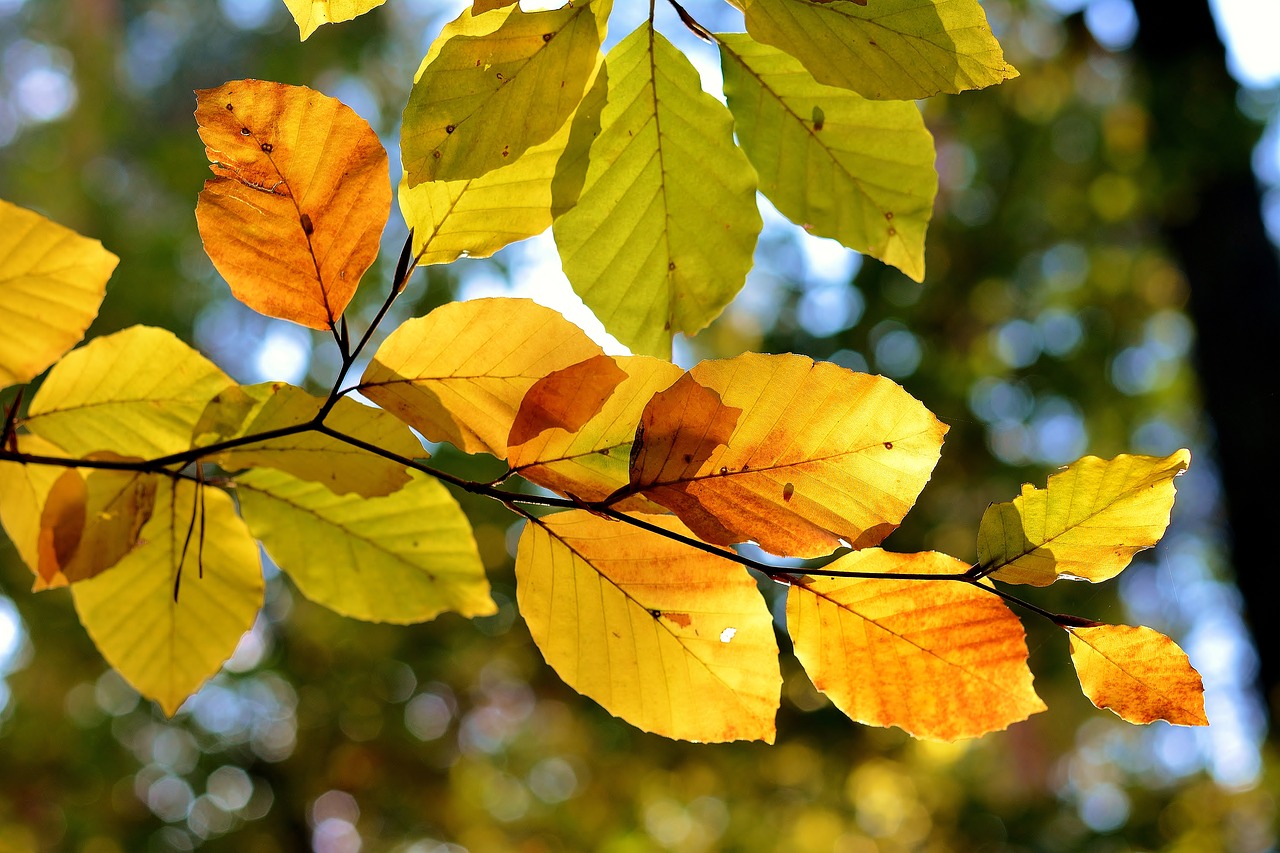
(401, 0, 612, 187)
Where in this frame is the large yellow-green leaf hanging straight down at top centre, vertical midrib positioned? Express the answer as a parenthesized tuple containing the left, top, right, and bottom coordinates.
(554, 23, 760, 359)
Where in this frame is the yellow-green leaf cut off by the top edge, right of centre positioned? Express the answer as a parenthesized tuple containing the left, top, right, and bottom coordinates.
(740, 0, 1018, 101)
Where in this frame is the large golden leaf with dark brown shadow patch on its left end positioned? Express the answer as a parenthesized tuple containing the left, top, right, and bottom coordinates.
(630, 352, 947, 557)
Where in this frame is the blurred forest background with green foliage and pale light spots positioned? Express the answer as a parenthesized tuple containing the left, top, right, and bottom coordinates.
(0, 0, 1280, 853)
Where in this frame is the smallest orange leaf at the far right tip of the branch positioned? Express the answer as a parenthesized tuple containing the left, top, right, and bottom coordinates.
(1066, 625, 1208, 726)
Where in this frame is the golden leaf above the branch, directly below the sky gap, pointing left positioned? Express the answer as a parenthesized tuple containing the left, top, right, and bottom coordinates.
(360, 298, 602, 457)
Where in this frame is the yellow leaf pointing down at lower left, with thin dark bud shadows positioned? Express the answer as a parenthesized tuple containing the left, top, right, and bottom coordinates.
(72, 480, 262, 716)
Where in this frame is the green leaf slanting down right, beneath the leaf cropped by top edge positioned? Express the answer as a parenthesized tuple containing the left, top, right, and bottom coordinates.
(717, 33, 938, 282)
